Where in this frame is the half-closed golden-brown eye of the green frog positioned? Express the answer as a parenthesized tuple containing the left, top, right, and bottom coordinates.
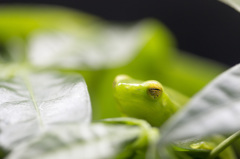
(144, 81, 163, 99)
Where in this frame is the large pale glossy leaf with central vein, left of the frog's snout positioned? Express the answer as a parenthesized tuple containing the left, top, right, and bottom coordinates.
(0, 72, 91, 149)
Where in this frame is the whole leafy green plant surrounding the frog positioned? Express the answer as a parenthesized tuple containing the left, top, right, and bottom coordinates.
(0, 1, 240, 159)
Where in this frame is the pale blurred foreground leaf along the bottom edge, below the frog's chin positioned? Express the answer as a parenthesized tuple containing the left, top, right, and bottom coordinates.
(7, 118, 158, 159)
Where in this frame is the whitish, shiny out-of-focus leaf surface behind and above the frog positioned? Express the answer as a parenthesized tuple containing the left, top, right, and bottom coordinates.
(28, 22, 148, 70)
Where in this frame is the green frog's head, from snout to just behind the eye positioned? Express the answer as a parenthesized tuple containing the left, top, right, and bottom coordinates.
(113, 75, 169, 126)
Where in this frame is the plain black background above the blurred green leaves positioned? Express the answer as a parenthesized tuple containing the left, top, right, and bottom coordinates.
(0, 0, 240, 66)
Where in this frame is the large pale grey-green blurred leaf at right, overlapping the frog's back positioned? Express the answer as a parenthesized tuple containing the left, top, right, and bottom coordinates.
(160, 65, 240, 144)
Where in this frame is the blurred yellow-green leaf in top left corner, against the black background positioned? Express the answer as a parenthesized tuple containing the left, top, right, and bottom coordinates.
(0, 5, 98, 42)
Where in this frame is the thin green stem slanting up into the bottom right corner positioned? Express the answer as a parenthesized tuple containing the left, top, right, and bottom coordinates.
(208, 131, 240, 159)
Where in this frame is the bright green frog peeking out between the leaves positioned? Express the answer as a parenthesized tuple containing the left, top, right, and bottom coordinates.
(113, 75, 188, 127)
